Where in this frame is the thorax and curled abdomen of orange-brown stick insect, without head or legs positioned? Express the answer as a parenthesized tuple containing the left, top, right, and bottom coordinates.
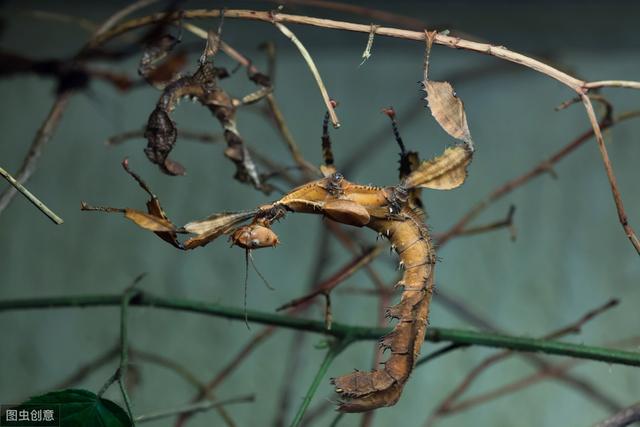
(264, 175, 435, 412)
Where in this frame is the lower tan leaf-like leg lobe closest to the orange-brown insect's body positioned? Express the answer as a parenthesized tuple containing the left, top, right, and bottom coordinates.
(404, 144, 472, 190)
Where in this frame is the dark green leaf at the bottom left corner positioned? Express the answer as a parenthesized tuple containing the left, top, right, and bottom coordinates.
(24, 389, 132, 427)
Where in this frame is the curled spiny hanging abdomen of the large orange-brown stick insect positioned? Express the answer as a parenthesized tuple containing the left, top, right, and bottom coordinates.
(331, 207, 435, 412)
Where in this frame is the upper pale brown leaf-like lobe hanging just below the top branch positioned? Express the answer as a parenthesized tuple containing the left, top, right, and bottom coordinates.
(422, 80, 473, 144)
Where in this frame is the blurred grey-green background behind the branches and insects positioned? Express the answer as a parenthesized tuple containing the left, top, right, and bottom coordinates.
(0, 1, 640, 427)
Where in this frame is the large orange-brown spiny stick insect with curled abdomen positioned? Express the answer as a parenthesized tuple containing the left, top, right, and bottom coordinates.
(83, 102, 473, 412)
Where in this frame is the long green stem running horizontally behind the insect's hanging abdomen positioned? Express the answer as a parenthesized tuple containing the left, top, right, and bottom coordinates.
(0, 292, 640, 366)
